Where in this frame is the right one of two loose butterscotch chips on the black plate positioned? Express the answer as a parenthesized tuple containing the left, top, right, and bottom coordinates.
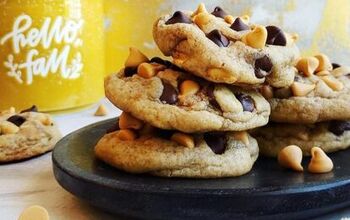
(308, 147, 333, 173)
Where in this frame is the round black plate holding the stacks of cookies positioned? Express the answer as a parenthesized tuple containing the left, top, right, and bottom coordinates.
(53, 119, 350, 219)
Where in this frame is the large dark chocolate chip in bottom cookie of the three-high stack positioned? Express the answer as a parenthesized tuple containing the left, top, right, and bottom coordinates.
(203, 132, 227, 154)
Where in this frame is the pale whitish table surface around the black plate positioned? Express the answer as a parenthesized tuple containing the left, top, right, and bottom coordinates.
(0, 100, 350, 220)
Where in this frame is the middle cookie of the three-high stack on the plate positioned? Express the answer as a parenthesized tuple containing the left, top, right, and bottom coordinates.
(105, 49, 270, 133)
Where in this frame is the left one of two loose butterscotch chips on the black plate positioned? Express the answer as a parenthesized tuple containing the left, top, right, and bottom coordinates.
(278, 145, 304, 172)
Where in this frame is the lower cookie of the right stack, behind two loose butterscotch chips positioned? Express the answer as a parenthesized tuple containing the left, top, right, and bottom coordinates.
(251, 121, 350, 157)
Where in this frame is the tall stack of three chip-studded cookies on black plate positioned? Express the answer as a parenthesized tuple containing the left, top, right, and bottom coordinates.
(95, 4, 299, 178)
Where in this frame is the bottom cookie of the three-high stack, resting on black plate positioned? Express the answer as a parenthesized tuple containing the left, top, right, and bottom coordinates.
(95, 113, 259, 178)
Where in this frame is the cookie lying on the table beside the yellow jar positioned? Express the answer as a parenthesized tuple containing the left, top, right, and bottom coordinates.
(0, 107, 61, 163)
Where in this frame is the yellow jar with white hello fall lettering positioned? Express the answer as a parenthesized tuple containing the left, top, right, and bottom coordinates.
(0, 0, 105, 111)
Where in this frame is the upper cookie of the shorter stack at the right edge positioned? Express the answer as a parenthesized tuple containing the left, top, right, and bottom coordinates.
(262, 55, 350, 124)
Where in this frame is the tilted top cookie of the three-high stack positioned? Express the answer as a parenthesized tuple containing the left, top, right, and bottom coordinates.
(153, 5, 299, 87)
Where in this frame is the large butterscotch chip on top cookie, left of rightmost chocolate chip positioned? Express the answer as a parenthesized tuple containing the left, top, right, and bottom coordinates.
(242, 25, 267, 49)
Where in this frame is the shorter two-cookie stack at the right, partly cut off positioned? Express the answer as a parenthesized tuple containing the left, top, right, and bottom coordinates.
(254, 54, 350, 157)
